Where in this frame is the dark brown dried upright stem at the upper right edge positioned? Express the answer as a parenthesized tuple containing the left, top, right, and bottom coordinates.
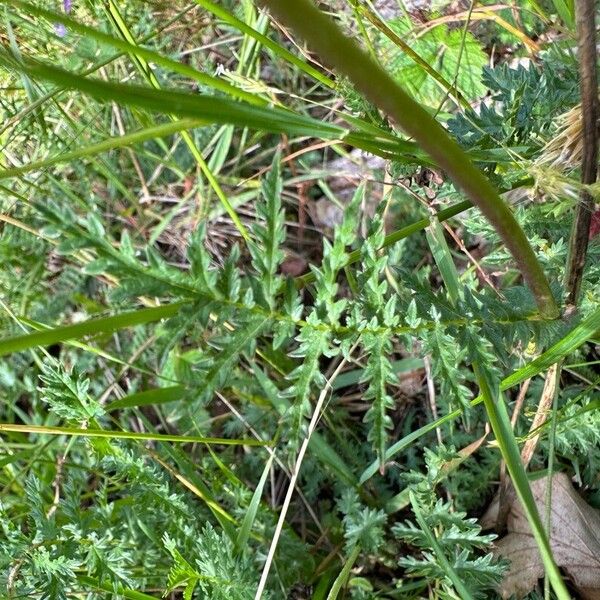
(566, 0, 599, 306)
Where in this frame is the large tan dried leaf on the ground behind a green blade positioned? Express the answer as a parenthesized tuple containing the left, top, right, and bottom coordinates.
(495, 473, 600, 600)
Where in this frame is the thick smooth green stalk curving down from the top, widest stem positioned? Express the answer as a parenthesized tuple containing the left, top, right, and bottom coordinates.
(261, 0, 559, 318)
